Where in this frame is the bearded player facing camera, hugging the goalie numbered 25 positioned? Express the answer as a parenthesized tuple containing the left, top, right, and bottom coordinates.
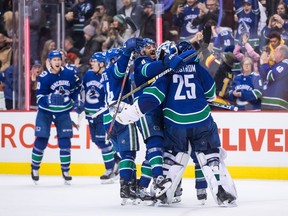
(134, 38, 171, 204)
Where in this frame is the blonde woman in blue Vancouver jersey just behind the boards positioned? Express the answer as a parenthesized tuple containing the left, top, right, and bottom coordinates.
(228, 57, 262, 111)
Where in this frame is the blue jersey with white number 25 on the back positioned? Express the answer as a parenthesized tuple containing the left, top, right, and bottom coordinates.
(138, 51, 216, 128)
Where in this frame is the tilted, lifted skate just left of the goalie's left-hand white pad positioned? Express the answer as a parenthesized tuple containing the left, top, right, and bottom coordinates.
(154, 176, 172, 206)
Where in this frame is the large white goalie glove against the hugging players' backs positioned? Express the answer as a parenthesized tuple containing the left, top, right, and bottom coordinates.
(109, 100, 144, 125)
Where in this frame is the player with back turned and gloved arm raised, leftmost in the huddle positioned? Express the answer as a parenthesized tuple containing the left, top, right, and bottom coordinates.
(102, 38, 142, 205)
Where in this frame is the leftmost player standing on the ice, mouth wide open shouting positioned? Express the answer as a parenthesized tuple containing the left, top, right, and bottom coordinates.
(31, 50, 84, 183)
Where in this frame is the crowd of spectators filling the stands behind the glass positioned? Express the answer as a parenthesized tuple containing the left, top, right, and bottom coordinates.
(0, 0, 288, 110)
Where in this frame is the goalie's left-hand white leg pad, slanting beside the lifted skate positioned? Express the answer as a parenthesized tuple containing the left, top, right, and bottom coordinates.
(166, 152, 190, 204)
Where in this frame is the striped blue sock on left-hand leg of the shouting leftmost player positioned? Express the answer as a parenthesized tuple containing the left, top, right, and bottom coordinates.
(31, 137, 48, 170)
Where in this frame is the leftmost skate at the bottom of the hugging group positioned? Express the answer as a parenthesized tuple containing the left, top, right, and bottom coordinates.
(120, 180, 136, 205)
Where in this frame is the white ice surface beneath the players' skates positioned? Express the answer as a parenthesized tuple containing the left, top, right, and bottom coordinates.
(0, 175, 288, 216)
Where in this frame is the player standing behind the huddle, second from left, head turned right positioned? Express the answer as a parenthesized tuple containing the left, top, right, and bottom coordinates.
(83, 52, 119, 184)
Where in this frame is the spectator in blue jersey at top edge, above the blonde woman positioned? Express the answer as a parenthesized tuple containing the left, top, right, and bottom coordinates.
(234, 0, 260, 48)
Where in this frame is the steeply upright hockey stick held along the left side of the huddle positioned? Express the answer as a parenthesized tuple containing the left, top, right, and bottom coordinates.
(104, 52, 134, 144)
